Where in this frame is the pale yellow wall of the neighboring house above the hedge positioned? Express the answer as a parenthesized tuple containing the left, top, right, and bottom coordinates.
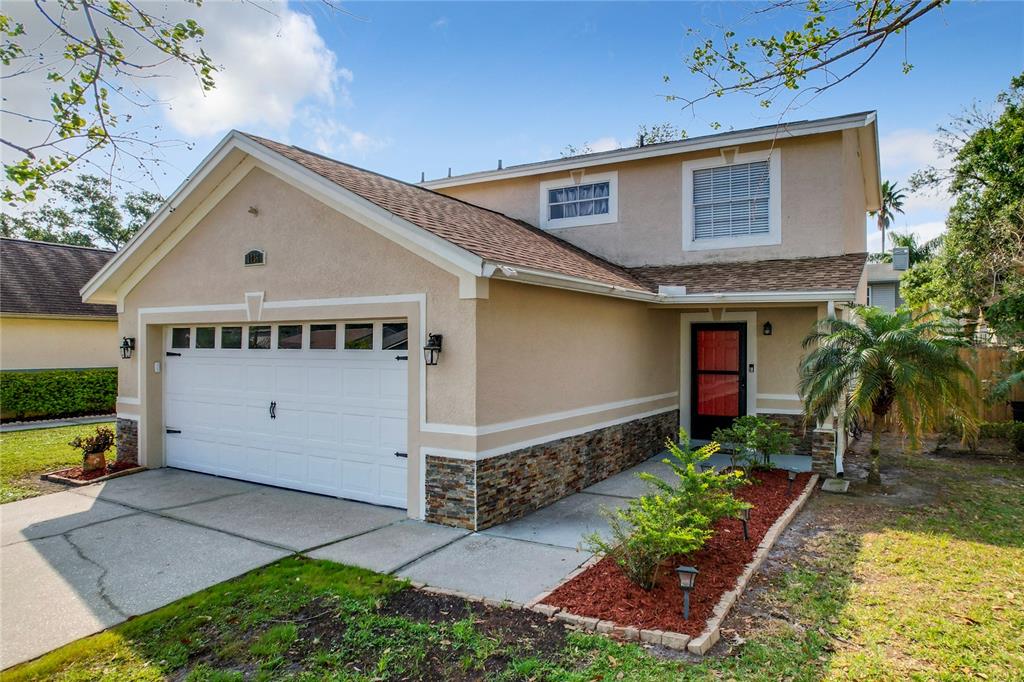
(0, 316, 121, 370)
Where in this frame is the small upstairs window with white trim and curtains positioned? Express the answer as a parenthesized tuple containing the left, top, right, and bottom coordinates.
(540, 172, 618, 229)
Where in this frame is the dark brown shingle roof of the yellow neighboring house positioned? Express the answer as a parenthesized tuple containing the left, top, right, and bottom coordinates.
(0, 239, 117, 317)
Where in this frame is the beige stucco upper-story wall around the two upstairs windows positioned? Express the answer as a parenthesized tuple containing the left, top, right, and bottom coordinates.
(439, 131, 866, 266)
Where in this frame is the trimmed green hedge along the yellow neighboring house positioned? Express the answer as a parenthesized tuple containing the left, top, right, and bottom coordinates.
(0, 368, 118, 421)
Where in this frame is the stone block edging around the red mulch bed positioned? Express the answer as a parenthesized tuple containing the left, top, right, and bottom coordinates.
(525, 474, 818, 655)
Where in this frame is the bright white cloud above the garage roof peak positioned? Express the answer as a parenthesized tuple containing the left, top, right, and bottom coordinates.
(156, 0, 342, 136)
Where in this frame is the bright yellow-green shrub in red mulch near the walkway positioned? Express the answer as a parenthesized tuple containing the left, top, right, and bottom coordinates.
(585, 429, 750, 590)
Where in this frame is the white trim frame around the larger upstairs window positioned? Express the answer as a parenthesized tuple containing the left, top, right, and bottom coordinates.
(683, 147, 782, 251)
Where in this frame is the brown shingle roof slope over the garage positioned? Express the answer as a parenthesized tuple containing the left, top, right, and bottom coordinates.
(241, 134, 647, 291)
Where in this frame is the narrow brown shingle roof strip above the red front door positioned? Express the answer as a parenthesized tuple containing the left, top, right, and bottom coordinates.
(630, 253, 867, 294)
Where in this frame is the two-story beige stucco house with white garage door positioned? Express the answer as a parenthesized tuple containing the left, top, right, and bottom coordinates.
(82, 114, 879, 528)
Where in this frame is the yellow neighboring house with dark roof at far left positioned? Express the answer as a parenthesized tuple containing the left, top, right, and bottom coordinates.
(0, 239, 120, 371)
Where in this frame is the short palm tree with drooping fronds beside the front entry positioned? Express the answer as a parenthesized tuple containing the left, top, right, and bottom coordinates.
(800, 307, 978, 484)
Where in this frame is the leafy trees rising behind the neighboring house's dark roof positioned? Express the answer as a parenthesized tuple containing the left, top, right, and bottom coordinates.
(0, 175, 164, 249)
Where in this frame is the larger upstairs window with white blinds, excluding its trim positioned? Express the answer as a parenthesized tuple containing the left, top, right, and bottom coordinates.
(693, 161, 770, 241)
